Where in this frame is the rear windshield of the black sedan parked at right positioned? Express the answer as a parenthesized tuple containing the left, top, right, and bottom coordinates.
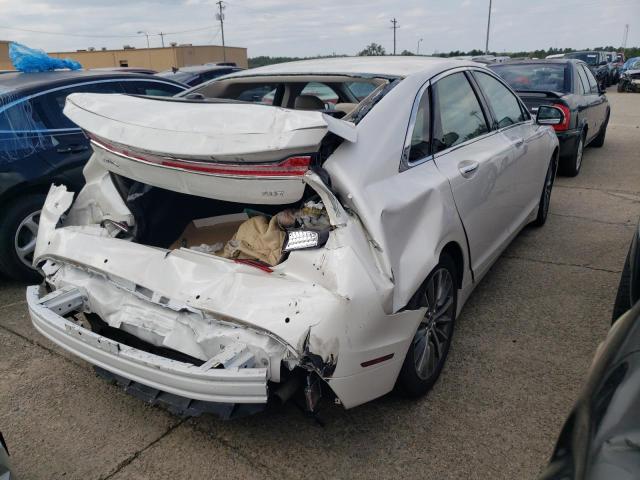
(491, 63, 570, 92)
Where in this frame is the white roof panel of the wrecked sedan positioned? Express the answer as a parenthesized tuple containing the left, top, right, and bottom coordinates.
(219, 56, 483, 79)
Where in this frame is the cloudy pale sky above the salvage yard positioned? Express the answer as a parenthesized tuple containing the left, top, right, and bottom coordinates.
(0, 0, 640, 57)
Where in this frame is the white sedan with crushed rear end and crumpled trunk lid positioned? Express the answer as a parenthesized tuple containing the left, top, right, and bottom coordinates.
(27, 57, 563, 417)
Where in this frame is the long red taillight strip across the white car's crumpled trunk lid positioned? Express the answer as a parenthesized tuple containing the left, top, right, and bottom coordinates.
(89, 134, 311, 177)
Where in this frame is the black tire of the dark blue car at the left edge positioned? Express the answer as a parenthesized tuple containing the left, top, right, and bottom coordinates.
(0, 194, 46, 282)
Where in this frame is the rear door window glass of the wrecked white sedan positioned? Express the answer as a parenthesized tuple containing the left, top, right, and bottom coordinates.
(433, 73, 489, 152)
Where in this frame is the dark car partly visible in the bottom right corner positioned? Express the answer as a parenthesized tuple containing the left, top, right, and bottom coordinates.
(540, 226, 640, 480)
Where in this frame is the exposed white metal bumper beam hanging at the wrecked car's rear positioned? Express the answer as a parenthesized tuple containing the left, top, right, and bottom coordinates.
(27, 286, 267, 404)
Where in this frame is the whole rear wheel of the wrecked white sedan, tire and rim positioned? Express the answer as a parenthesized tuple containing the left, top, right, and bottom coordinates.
(398, 255, 458, 397)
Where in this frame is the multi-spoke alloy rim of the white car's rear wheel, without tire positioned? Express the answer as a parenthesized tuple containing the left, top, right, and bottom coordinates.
(413, 268, 455, 380)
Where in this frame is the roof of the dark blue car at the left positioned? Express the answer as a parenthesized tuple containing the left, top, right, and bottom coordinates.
(0, 70, 184, 93)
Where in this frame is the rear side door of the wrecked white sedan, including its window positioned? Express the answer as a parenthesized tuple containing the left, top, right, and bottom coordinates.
(432, 71, 514, 276)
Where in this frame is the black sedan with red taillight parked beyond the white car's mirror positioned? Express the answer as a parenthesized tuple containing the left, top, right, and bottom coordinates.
(489, 58, 611, 177)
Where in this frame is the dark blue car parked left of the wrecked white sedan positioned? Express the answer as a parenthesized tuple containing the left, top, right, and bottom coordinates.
(0, 71, 185, 280)
